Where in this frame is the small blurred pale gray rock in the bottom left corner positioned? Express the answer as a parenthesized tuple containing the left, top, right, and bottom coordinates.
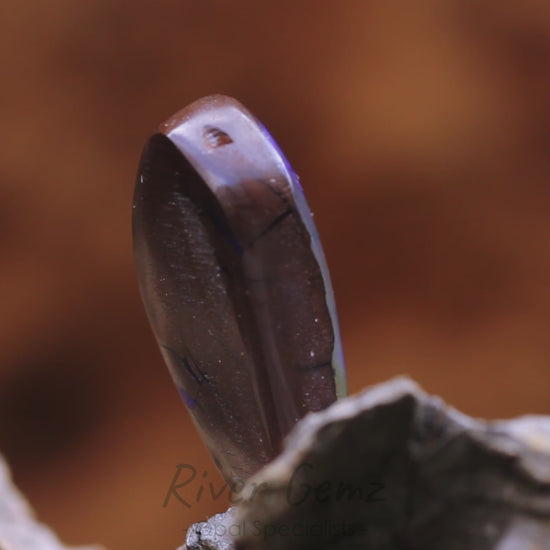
(0, 456, 101, 550)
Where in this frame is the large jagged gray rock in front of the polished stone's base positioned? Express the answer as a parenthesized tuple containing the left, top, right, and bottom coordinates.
(183, 378, 550, 550)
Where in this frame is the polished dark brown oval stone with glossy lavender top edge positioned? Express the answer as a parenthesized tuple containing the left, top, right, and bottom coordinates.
(133, 96, 346, 486)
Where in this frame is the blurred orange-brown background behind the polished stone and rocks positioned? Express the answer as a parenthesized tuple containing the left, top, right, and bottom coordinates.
(0, 0, 550, 550)
